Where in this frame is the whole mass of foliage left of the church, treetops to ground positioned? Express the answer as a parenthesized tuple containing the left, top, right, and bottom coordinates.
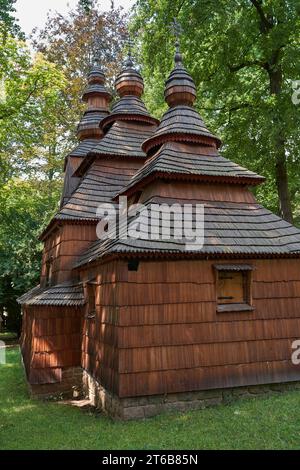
(0, 0, 125, 330)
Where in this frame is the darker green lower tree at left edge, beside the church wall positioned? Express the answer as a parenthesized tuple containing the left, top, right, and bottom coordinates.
(0, 178, 60, 332)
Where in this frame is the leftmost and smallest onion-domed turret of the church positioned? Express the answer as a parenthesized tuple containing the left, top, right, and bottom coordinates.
(77, 60, 111, 140)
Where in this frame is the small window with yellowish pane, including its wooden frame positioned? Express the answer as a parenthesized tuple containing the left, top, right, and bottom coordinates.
(215, 264, 253, 312)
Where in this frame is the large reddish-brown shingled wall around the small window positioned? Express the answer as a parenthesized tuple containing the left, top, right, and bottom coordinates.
(106, 260, 300, 397)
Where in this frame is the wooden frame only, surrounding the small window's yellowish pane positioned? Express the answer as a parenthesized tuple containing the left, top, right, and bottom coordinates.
(214, 264, 255, 313)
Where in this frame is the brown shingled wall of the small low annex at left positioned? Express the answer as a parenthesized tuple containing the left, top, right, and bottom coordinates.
(21, 306, 82, 384)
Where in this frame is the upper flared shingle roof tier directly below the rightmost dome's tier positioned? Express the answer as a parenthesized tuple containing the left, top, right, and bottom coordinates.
(117, 142, 264, 195)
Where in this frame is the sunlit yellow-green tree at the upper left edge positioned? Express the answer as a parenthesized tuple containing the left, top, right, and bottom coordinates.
(0, 37, 67, 184)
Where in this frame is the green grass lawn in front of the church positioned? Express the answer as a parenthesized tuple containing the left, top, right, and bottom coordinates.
(0, 348, 300, 450)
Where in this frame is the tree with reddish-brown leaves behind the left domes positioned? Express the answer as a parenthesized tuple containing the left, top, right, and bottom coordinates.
(32, 0, 126, 169)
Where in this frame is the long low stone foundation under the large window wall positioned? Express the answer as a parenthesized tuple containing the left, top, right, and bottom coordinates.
(83, 371, 300, 420)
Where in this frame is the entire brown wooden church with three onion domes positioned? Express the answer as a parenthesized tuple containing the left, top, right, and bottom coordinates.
(19, 39, 300, 419)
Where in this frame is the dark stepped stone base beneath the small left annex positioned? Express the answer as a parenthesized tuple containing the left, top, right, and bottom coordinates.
(28, 367, 82, 400)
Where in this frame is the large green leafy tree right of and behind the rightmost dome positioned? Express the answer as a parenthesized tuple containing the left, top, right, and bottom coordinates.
(132, 0, 300, 222)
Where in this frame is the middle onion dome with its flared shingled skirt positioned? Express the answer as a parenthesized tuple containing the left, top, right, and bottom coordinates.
(101, 54, 159, 129)
